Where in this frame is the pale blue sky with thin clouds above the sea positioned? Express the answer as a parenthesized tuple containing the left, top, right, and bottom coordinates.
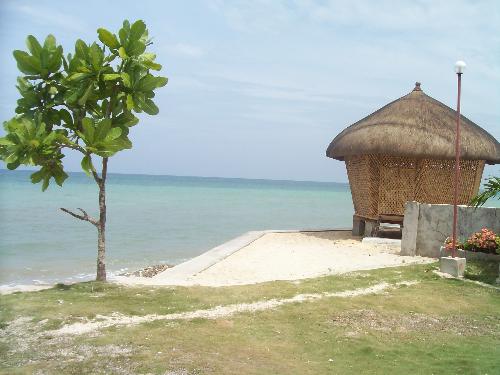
(0, 0, 500, 182)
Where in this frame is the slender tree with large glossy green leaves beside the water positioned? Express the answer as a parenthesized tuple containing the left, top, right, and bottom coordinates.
(0, 20, 167, 281)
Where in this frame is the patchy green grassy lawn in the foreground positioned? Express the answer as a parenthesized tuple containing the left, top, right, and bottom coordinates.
(0, 264, 500, 375)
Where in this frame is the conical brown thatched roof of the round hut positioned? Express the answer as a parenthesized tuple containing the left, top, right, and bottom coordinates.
(326, 82, 500, 164)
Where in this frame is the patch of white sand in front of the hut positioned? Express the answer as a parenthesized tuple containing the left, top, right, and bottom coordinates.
(118, 231, 434, 286)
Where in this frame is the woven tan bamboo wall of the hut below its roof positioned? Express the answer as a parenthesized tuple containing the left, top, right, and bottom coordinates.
(346, 155, 484, 219)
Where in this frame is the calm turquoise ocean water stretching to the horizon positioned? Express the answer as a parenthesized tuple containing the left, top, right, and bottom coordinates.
(0, 170, 353, 285)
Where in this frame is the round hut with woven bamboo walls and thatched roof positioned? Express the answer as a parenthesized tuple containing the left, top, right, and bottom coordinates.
(326, 82, 500, 235)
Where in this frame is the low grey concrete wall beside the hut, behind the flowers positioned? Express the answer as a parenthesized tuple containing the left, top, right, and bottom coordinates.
(401, 202, 500, 258)
